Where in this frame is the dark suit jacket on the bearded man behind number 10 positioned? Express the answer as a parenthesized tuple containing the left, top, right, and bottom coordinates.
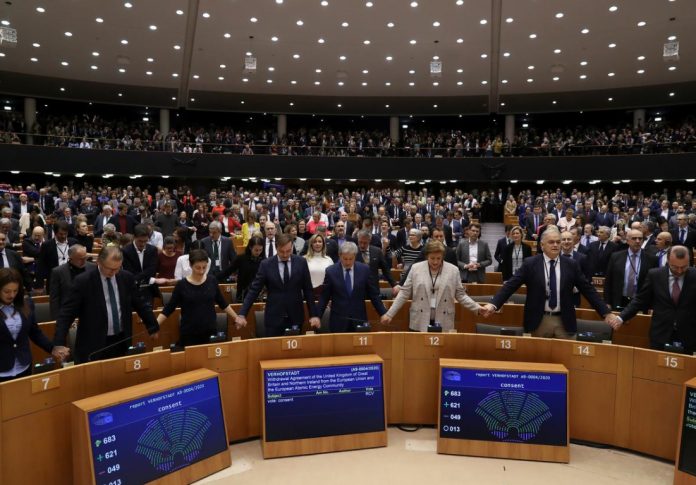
(239, 255, 319, 335)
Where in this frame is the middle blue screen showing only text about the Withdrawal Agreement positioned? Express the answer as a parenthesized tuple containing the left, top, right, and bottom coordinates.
(263, 364, 385, 441)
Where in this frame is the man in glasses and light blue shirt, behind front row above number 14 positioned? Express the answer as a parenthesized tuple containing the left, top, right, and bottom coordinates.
(604, 229, 657, 308)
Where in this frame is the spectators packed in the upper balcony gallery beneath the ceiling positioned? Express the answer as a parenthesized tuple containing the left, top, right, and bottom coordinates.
(0, 108, 696, 158)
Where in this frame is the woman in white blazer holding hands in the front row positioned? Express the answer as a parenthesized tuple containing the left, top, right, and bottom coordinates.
(381, 240, 480, 332)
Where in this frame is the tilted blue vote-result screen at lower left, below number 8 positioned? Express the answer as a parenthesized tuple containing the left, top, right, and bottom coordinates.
(88, 377, 228, 485)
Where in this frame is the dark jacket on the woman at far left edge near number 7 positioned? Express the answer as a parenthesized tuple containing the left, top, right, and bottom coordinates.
(0, 303, 53, 372)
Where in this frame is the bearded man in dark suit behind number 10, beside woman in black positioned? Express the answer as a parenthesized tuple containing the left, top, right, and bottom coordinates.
(236, 234, 321, 337)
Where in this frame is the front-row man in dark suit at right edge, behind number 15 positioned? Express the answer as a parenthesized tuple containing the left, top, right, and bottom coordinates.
(610, 246, 696, 354)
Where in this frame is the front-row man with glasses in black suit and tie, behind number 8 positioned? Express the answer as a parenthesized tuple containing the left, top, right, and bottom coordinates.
(54, 246, 159, 364)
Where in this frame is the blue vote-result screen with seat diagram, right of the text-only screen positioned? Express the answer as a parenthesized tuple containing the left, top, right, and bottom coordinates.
(440, 367, 568, 446)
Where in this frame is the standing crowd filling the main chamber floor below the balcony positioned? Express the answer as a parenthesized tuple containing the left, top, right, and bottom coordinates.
(0, 178, 696, 379)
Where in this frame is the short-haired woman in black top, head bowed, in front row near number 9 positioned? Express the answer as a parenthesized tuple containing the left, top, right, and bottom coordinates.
(157, 249, 243, 347)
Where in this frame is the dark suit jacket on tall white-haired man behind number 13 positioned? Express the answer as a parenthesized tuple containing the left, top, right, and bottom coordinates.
(491, 254, 609, 333)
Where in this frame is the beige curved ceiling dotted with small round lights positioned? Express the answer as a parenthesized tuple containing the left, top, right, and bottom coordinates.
(0, 0, 696, 114)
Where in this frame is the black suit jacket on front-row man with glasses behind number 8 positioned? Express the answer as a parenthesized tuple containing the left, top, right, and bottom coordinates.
(53, 269, 159, 363)
